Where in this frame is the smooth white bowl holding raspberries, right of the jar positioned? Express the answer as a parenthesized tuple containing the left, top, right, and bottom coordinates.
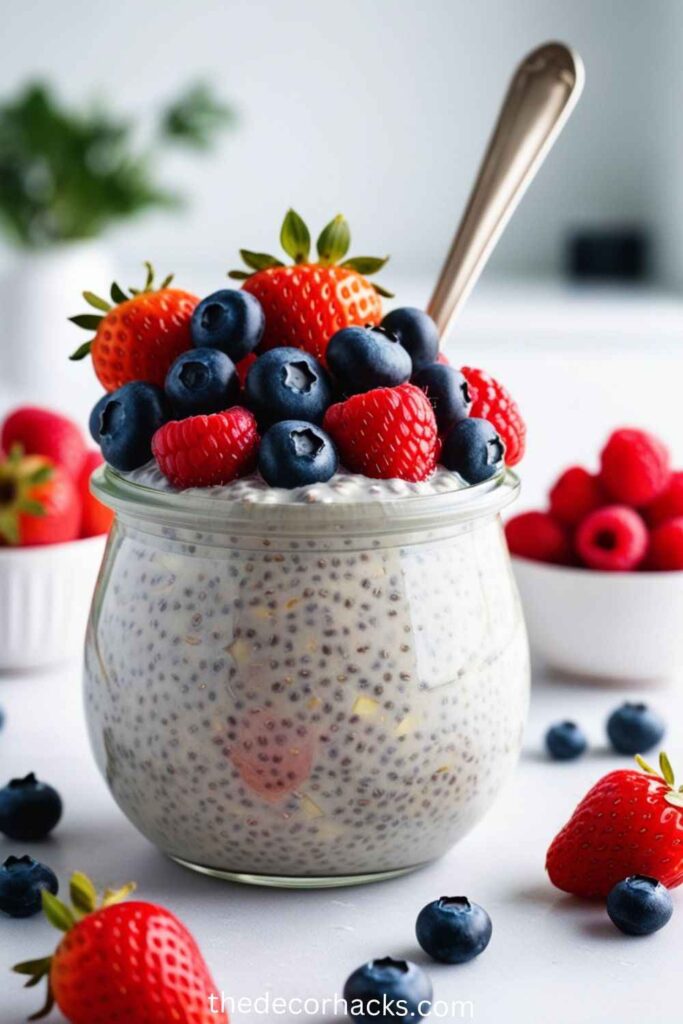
(512, 558, 683, 680)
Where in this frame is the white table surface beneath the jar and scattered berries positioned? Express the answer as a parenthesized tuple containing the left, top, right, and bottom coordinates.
(0, 665, 683, 1024)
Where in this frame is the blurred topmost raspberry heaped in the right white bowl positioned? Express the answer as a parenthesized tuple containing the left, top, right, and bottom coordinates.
(599, 428, 671, 508)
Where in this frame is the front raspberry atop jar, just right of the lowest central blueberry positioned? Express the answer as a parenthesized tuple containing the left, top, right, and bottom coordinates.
(323, 384, 437, 480)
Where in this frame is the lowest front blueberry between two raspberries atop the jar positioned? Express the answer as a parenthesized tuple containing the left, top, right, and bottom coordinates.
(258, 420, 337, 487)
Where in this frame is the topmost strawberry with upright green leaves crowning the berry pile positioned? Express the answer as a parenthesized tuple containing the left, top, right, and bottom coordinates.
(229, 210, 391, 361)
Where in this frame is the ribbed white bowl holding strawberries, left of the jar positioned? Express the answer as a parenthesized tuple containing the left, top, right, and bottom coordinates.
(0, 537, 106, 671)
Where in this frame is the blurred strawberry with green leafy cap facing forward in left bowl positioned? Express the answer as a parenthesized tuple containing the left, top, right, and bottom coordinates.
(0, 444, 81, 547)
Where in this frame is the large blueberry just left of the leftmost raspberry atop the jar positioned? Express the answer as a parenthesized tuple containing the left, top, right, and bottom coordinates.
(90, 381, 168, 472)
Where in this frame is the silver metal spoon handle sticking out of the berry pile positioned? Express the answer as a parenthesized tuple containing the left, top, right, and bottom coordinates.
(427, 43, 584, 337)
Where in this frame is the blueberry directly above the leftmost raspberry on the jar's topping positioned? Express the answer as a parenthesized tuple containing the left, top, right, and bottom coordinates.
(166, 348, 240, 420)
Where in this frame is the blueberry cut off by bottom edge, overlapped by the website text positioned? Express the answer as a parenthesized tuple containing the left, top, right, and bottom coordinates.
(344, 956, 432, 1024)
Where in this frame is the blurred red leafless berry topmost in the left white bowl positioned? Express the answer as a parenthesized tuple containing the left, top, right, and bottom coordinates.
(0, 406, 86, 480)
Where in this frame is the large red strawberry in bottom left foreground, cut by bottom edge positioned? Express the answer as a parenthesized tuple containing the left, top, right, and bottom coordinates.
(12, 871, 228, 1024)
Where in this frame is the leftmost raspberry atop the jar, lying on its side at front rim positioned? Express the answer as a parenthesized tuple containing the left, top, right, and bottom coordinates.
(152, 406, 259, 487)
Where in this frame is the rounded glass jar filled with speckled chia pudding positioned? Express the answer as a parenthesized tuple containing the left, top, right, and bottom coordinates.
(85, 468, 529, 887)
